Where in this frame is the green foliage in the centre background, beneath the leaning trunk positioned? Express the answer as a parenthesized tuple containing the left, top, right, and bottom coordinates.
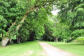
(20, 8, 48, 39)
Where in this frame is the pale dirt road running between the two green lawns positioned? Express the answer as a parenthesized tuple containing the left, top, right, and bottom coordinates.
(39, 42, 75, 56)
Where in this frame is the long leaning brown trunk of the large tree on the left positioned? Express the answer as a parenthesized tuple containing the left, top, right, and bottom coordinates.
(1, 8, 36, 47)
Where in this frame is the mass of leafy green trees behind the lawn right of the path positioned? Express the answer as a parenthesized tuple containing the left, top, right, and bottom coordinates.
(40, 0, 84, 42)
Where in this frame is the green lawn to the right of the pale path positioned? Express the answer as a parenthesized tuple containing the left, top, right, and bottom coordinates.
(48, 42, 84, 56)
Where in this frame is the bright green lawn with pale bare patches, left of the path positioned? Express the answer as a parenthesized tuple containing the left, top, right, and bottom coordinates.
(0, 41, 44, 56)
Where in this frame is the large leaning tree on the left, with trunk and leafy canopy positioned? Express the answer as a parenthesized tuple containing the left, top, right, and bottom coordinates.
(0, 0, 54, 46)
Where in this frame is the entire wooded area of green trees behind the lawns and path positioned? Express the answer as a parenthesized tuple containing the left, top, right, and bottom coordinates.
(0, 0, 84, 46)
